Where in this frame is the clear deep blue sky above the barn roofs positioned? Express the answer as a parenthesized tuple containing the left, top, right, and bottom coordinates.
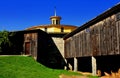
(0, 0, 120, 31)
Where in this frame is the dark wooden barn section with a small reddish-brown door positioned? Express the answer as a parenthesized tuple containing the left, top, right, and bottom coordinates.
(13, 29, 66, 69)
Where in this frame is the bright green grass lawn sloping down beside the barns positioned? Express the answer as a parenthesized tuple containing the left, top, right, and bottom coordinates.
(0, 56, 97, 78)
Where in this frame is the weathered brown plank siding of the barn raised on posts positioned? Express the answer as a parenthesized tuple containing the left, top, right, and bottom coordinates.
(65, 14, 120, 58)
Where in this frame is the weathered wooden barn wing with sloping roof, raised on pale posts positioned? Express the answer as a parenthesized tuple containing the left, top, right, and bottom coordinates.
(64, 3, 120, 75)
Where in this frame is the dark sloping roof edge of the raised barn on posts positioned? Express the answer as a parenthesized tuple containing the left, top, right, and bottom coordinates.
(64, 3, 120, 40)
